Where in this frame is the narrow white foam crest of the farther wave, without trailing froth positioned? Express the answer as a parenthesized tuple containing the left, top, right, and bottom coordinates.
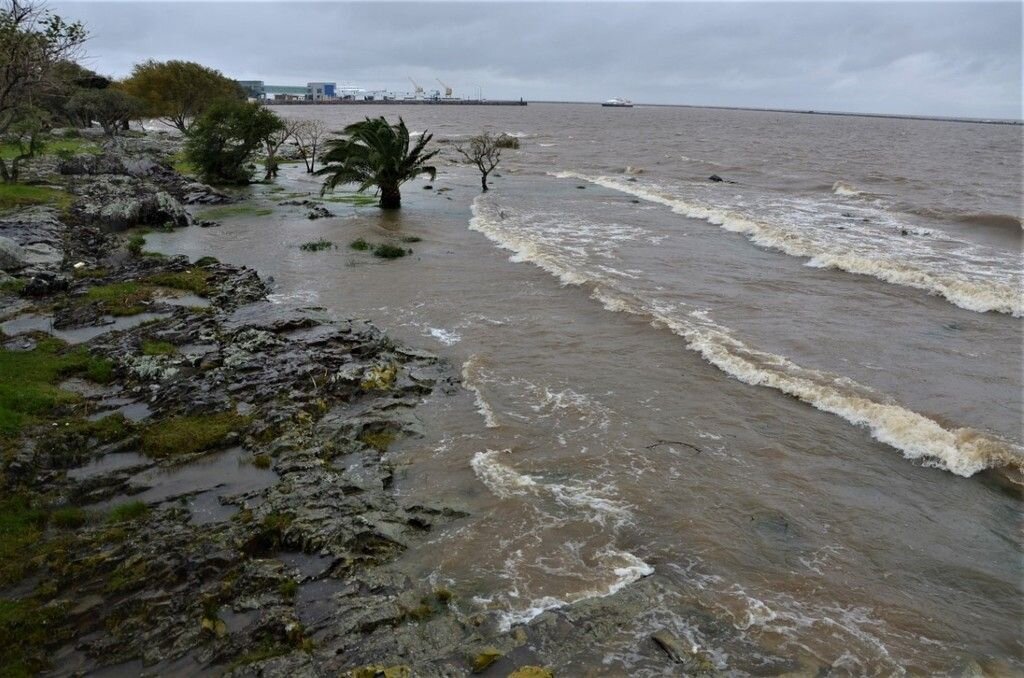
(551, 172, 1024, 316)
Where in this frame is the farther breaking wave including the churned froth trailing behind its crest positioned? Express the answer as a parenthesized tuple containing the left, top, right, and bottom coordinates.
(553, 172, 1024, 316)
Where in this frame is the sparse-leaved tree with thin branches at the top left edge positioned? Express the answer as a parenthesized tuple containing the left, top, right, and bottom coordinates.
(0, 0, 86, 181)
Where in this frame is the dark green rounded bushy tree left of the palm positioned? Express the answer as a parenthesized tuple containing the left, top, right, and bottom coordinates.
(185, 100, 284, 183)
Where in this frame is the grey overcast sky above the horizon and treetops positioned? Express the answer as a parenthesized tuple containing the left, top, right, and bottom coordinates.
(51, 0, 1022, 119)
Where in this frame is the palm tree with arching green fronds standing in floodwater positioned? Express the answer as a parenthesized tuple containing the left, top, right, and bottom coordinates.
(316, 116, 437, 209)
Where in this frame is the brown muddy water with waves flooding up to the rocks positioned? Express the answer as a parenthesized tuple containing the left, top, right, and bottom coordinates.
(147, 104, 1024, 676)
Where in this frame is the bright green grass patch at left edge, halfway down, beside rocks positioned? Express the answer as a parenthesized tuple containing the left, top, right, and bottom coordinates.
(0, 338, 114, 439)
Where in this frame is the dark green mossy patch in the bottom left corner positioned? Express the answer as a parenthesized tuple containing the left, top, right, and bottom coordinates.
(0, 599, 65, 678)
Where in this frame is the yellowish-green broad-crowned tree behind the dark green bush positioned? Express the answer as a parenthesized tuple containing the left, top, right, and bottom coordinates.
(123, 59, 246, 133)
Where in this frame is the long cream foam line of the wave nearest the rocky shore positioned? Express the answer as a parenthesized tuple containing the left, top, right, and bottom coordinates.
(470, 198, 1024, 477)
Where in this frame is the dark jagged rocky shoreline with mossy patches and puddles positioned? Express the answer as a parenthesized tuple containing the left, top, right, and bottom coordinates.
(0, 134, 797, 678)
